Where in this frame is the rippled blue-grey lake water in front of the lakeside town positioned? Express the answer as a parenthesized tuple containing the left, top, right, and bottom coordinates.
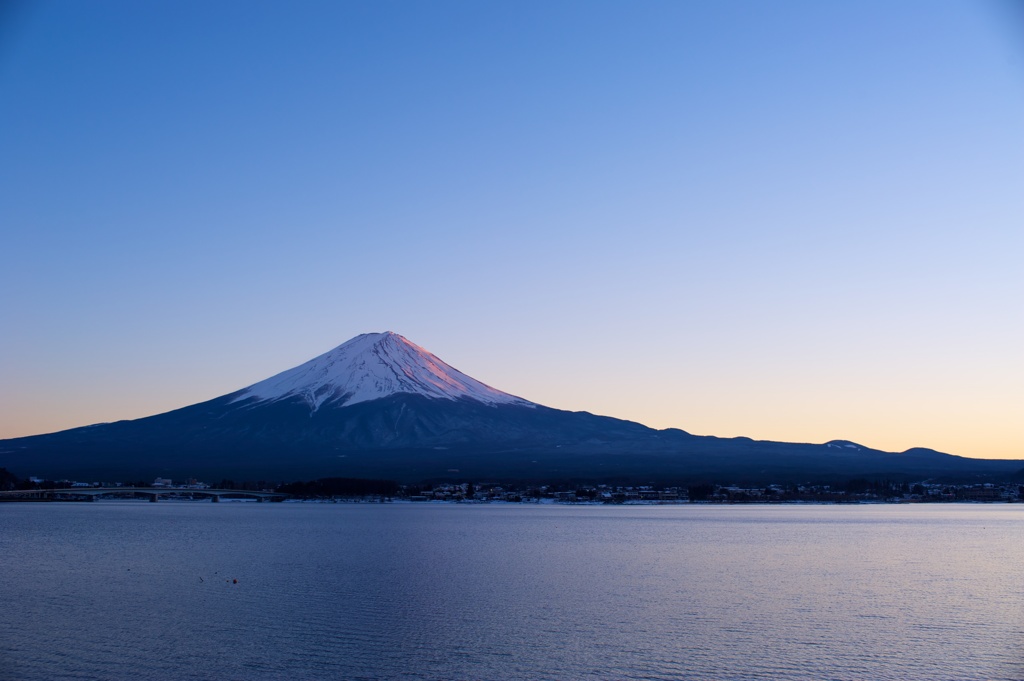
(0, 502, 1024, 681)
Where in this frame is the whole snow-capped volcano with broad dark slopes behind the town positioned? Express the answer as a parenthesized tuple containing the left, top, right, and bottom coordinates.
(0, 332, 1024, 483)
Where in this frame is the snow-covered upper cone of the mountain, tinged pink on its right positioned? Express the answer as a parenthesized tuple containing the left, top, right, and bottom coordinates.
(232, 331, 534, 412)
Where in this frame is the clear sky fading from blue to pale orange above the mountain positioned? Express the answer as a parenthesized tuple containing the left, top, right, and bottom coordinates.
(0, 0, 1024, 458)
